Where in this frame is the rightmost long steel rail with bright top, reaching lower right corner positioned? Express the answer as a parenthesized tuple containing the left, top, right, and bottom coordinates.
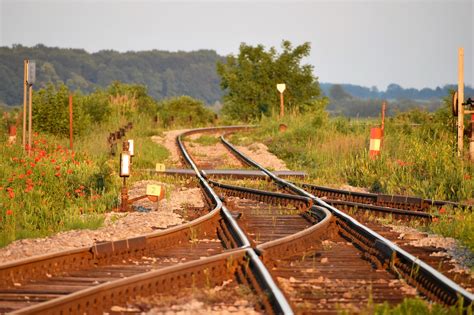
(221, 136, 474, 307)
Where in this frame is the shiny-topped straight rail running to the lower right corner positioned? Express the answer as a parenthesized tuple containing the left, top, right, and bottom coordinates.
(221, 136, 474, 309)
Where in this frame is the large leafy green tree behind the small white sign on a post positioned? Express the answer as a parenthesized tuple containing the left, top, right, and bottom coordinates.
(217, 41, 323, 121)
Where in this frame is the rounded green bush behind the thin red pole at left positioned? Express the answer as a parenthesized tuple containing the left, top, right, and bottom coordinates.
(33, 84, 91, 135)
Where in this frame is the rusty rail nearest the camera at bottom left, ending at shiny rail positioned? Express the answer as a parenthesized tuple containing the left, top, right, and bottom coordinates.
(11, 248, 252, 314)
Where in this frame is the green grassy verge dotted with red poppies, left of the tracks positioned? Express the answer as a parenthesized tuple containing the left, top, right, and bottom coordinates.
(0, 114, 169, 247)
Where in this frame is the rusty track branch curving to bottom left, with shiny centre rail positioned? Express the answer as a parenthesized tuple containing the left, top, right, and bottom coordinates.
(0, 126, 291, 314)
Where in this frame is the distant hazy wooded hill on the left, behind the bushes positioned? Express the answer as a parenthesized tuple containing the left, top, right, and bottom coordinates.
(0, 44, 223, 105)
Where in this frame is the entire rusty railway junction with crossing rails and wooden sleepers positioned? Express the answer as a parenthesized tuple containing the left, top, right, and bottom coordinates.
(0, 127, 472, 314)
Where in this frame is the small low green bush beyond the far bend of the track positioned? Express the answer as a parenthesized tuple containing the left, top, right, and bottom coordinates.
(158, 96, 216, 127)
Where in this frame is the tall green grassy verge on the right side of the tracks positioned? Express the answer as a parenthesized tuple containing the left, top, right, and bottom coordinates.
(231, 113, 474, 250)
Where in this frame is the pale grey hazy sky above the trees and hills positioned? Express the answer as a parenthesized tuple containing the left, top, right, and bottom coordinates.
(0, 0, 474, 90)
